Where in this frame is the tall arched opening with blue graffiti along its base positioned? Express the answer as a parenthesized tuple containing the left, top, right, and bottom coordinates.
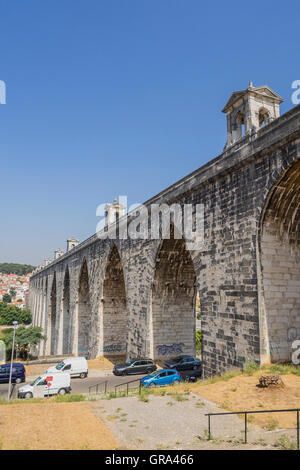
(150, 225, 196, 359)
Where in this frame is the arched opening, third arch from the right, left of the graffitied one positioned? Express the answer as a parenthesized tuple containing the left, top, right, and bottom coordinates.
(102, 245, 128, 356)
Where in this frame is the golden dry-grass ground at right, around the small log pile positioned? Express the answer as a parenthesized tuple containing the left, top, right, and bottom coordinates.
(191, 371, 300, 429)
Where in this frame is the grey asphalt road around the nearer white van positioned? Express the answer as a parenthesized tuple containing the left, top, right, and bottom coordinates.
(0, 374, 145, 398)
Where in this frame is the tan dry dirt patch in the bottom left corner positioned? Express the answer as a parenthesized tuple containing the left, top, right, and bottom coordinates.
(0, 402, 118, 450)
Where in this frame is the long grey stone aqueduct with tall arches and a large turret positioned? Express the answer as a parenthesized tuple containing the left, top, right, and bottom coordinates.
(29, 83, 300, 374)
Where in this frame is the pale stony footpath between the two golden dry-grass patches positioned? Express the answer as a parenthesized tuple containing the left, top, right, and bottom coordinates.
(90, 393, 296, 450)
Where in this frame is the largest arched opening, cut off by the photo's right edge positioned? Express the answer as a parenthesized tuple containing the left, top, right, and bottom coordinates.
(260, 160, 300, 362)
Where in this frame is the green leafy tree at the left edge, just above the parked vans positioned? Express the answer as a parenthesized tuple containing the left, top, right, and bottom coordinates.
(2, 326, 46, 359)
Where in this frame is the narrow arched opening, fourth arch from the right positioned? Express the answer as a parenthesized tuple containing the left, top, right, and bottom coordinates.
(77, 260, 91, 356)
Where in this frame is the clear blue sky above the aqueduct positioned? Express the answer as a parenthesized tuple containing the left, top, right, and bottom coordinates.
(0, 0, 300, 264)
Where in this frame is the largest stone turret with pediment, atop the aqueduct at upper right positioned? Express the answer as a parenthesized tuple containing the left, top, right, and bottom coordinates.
(222, 82, 283, 149)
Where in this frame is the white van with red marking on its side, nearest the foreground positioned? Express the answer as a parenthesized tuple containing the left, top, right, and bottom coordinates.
(18, 373, 71, 398)
